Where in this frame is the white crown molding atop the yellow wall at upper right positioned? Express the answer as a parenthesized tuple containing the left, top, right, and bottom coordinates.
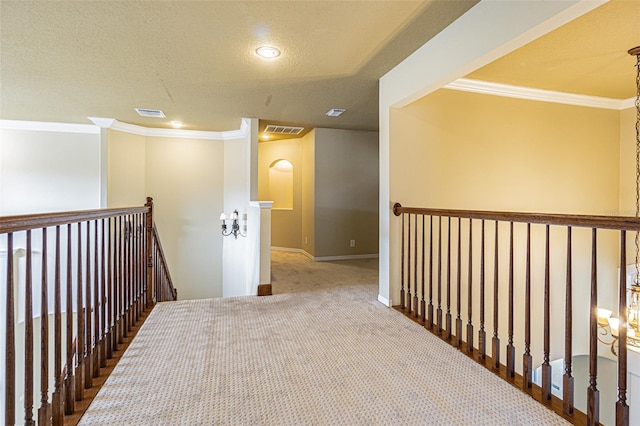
(444, 78, 635, 110)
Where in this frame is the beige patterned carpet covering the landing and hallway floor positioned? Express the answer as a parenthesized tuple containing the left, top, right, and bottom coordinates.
(80, 253, 566, 425)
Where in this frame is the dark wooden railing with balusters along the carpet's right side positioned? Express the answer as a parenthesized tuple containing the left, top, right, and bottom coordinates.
(393, 204, 640, 426)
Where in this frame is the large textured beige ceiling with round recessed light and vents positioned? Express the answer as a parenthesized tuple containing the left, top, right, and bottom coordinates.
(0, 0, 476, 131)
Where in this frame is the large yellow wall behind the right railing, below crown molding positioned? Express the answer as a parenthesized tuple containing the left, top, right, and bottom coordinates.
(390, 90, 620, 365)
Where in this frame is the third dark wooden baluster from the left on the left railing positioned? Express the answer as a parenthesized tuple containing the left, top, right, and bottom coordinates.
(38, 228, 51, 425)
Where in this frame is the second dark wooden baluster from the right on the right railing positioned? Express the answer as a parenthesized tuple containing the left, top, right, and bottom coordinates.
(587, 228, 600, 426)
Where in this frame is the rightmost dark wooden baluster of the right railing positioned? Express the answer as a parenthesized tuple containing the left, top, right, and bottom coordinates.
(616, 230, 640, 426)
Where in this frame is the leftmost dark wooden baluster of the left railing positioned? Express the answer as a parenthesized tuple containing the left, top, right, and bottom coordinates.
(4, 232, 16, 425)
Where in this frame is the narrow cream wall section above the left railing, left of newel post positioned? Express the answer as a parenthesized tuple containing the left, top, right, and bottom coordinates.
(107, 129, 147, 207)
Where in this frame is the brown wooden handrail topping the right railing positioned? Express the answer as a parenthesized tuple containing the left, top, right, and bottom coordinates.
(393, 203, 640, 231)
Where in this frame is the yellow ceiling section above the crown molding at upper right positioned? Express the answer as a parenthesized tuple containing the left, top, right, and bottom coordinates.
(467, 0, 640, 99)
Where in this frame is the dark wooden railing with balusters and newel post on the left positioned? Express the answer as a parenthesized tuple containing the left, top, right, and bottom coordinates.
(0, 198, 177, 425)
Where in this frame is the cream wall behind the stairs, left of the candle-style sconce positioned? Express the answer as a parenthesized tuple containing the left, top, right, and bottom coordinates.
(146, 137, 224, 299)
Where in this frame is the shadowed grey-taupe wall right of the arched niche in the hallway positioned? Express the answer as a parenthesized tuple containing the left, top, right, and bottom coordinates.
(315, 129, 379, 258)
